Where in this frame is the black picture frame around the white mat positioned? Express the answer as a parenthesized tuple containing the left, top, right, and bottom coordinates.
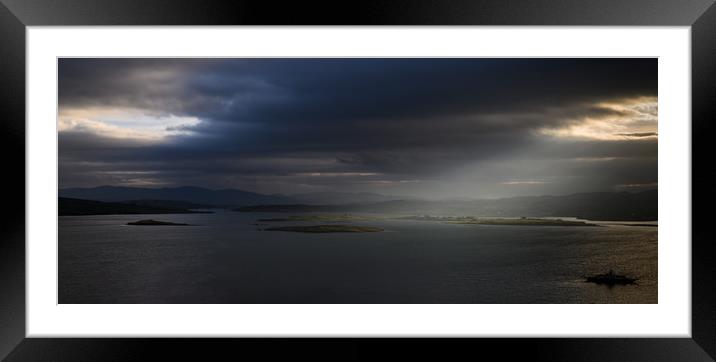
(0, 0, 716, 361)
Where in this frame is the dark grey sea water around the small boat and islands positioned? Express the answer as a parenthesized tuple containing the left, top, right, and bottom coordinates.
(59, 212, 657, 303)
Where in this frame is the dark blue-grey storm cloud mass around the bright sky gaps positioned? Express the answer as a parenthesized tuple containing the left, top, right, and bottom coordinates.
(59, 59, 657, 197)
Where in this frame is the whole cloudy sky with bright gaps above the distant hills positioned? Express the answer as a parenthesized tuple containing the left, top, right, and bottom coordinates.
(58, 58, 658, 199)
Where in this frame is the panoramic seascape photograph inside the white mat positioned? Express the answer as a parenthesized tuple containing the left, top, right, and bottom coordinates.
(57, 57, 663, 304)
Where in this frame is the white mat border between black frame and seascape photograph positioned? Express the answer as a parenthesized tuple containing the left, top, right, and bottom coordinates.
(27, 27, 691, 337)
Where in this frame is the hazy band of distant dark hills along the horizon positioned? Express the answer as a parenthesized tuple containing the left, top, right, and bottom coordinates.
(59, 186, 658, 220)
